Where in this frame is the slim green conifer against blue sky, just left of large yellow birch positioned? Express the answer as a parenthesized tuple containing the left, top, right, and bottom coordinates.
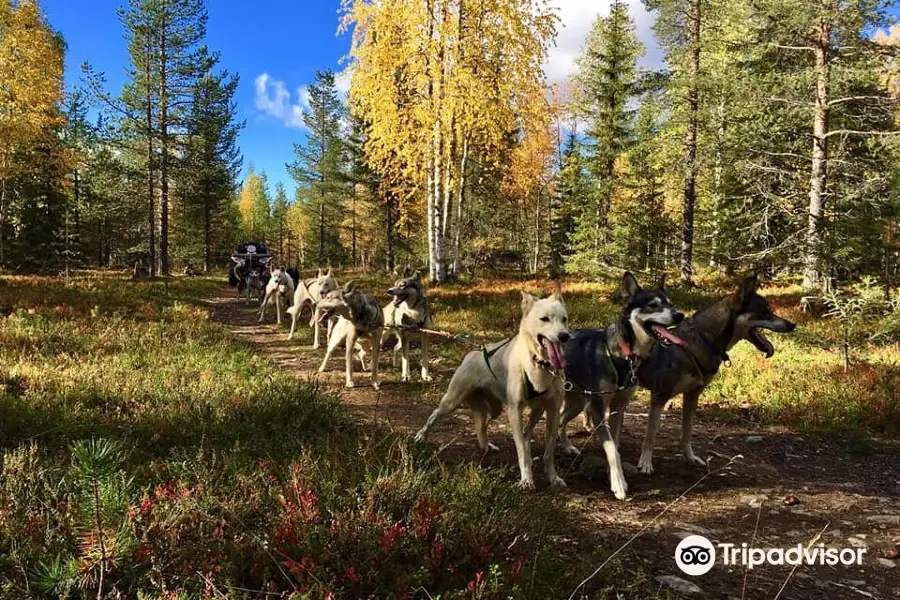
(287, 70, 347, 267)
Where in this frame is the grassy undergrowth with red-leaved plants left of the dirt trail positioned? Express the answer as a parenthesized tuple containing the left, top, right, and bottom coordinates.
(0, 273, 612, 598)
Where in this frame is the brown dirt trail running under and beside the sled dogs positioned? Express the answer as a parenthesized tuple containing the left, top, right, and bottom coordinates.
(208, 289, 900, 599)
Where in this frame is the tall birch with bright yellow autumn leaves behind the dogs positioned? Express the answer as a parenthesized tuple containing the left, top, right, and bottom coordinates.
(343, 0, 555, 283)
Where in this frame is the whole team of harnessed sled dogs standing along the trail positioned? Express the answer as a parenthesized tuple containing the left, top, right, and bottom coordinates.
(251, 268, 796, 500)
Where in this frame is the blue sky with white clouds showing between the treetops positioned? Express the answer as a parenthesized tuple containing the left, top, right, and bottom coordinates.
(41, 0, 661, 198)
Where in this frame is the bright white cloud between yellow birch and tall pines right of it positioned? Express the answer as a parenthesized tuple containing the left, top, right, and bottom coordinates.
(544, 0, 663, 83)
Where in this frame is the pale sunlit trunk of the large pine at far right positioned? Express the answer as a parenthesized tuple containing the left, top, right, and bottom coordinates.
(803, 20, 831, 288)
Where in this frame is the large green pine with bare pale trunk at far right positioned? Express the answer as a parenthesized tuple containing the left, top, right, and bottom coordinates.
(719, 0, 896, 287)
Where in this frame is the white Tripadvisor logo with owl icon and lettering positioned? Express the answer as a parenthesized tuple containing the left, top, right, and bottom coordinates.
(675, 535, 866, 575)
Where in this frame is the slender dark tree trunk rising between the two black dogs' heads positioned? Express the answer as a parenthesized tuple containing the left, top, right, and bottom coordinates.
(681, 0, 701, 283)
